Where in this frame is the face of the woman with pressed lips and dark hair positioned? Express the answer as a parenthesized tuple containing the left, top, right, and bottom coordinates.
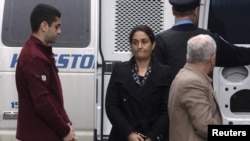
(131, 31, 155, 60)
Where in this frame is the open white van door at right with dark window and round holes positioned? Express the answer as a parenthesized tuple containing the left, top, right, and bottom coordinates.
(202, 0, 250, 124)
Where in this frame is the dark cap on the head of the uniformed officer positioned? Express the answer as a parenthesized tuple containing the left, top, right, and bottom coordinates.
(169, 0, 200, 12)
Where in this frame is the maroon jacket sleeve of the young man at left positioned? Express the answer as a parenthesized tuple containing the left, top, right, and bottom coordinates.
(23, 58, 70, 138)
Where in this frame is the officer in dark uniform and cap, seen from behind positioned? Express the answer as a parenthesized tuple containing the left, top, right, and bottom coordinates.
(155, 0, 250, 76)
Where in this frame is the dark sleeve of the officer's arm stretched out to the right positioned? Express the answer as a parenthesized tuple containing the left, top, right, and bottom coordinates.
(212, 33, 250, 67)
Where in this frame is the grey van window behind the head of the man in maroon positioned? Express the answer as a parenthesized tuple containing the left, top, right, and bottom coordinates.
(2, 0, 90, 48)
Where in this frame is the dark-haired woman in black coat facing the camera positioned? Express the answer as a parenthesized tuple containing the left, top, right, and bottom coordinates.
(105, 25, 171, 141)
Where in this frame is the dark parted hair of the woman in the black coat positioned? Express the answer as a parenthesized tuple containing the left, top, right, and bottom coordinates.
(129, 25, 155, 44)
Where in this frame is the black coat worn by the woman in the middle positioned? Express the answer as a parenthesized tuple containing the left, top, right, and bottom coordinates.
(105, 58, 171, 141)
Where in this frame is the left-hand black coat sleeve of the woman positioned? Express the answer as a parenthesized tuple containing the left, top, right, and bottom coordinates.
(105, 63, 134, 139)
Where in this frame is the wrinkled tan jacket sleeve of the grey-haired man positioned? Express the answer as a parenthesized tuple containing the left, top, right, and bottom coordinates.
(180, 80, 221, 139)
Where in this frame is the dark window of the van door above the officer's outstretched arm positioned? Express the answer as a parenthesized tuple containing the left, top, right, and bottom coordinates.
(208, 0, 250, 44)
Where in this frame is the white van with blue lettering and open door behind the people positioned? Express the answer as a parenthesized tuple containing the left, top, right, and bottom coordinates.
(0, 0, 250, 141)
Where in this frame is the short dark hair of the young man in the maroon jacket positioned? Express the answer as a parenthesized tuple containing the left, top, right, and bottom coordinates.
(30, 3, 61, 33)
